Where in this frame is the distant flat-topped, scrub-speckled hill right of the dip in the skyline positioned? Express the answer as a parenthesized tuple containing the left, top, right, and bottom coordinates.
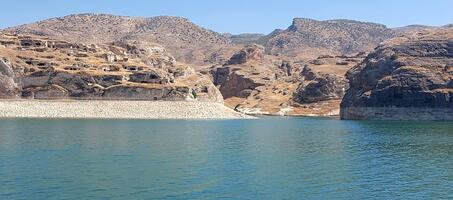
(264, 18, 395, 57)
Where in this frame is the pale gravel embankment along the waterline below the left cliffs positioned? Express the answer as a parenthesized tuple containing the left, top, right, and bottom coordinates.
(0, 100, 253, 119)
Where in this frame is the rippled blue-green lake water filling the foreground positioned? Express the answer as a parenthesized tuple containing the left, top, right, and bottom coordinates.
(0, 118, 453, 199)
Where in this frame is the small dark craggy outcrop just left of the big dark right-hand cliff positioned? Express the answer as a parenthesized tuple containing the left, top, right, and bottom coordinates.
(294, 67, 348, 103)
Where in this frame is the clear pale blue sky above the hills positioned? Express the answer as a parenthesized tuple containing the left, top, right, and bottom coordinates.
(0, 0, 453, 33)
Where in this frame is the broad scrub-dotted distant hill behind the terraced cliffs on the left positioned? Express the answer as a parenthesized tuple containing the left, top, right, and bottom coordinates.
(5, 14, 231, 64)
